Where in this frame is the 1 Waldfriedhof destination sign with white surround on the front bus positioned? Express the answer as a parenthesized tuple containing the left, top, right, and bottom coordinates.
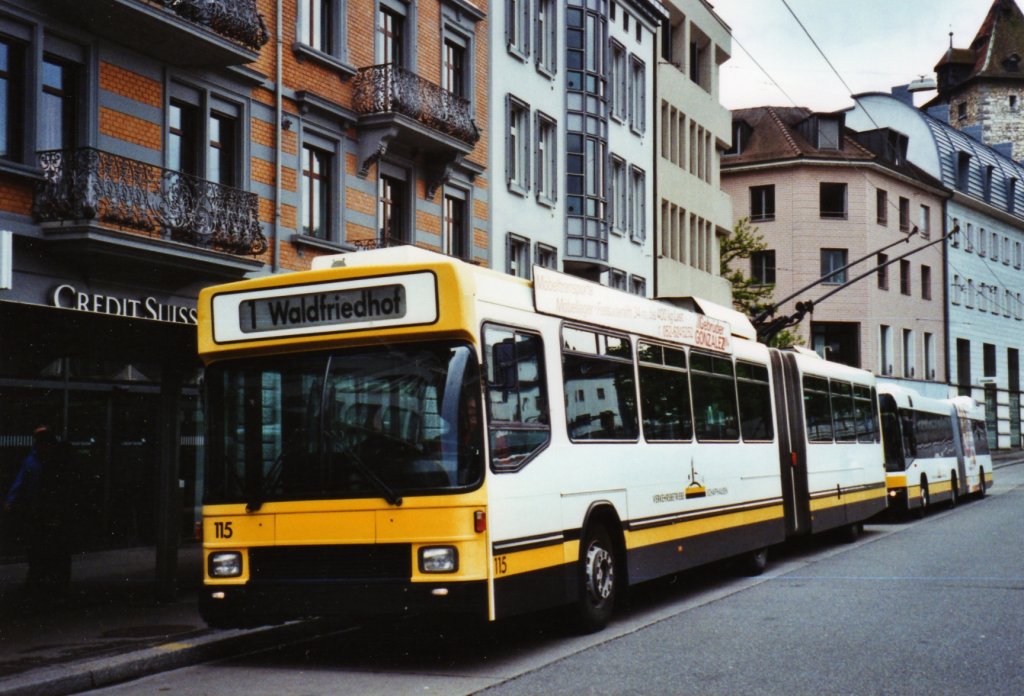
(213, 272, 437, 343)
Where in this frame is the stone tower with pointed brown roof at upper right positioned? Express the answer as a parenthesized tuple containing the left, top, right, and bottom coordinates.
(928, 0, 1024, 160)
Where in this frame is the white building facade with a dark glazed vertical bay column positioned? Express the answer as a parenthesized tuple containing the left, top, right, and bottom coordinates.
(488, 0, 664, 296)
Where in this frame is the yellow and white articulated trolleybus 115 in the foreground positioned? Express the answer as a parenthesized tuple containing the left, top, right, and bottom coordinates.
(199, 247, 886, 629)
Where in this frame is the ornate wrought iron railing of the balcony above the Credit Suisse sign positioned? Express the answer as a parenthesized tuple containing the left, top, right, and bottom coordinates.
(33, 147, 267, 255)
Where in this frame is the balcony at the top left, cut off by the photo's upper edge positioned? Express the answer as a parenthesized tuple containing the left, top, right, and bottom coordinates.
(43, 0, 269, 67)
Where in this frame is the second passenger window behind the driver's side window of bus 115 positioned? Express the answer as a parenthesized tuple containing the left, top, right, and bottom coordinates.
(637, 343, 693, 442)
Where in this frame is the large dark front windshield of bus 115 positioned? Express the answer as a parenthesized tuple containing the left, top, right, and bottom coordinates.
(206, 342, 482, 510)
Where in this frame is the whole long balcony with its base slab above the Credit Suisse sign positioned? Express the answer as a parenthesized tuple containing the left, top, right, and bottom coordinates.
(33, 147, 268, 275)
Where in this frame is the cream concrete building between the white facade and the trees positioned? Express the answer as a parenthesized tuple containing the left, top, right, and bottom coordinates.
(654, 0, 732, 306)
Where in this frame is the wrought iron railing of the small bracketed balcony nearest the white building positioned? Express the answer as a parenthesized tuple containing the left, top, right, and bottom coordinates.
(353, 64, 480, 145)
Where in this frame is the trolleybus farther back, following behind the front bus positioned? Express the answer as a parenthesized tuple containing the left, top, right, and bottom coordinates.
(879, 384, 992, 516)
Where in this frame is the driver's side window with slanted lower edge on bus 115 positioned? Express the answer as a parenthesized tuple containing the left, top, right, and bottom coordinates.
(483, 325, 551, 472)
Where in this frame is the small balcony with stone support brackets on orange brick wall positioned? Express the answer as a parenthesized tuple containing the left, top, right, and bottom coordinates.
(352, 64, 480, 198)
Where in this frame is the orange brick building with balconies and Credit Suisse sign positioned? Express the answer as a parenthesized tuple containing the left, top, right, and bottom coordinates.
(0, 0, 490, 569)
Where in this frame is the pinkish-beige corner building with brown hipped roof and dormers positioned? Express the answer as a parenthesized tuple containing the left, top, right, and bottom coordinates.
(722, 106, 946, 391)
